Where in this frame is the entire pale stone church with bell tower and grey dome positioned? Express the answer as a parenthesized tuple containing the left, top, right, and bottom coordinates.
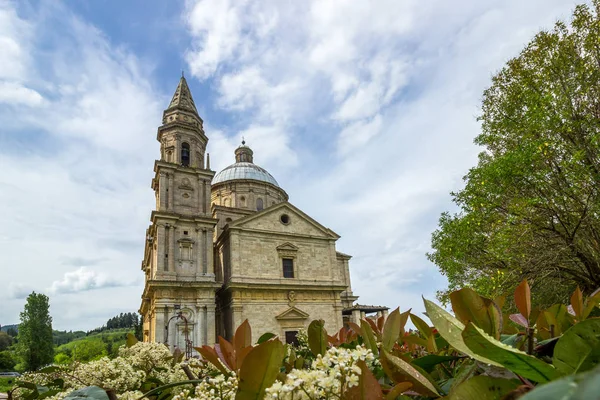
(140, 76, 387, 351)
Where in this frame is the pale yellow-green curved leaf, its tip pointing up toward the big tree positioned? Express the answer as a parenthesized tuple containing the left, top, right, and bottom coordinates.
(423, 299, 501, 367)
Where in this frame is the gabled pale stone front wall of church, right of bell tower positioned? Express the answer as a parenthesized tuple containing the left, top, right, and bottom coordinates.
(217, 203, 347, 337)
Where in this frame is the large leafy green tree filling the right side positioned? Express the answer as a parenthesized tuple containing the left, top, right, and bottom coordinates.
(428, 0, 600, 305)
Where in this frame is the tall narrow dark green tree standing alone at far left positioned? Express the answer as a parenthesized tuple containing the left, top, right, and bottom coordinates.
(17, 292, 54, 371)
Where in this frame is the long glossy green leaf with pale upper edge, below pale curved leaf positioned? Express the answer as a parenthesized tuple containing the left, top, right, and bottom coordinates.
(462, 322, 559, 382)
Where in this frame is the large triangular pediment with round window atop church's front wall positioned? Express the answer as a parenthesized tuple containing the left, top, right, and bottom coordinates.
(229, 201, 340, 239)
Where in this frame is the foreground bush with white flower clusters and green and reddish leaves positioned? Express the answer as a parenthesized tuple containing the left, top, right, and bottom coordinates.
(10, 281, 600, 400)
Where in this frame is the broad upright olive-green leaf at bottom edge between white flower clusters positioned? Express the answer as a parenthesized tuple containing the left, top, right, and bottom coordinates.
(235, 340, 285, 400)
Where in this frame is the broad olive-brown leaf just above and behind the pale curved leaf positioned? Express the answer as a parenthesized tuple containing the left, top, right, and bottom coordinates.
(450, 288, 502, 339)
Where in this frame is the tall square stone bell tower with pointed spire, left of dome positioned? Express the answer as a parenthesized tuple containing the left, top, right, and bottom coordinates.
(140, 75, 220, 350)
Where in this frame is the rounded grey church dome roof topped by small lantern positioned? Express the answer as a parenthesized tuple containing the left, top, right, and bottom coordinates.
(212, 141, 279, 187)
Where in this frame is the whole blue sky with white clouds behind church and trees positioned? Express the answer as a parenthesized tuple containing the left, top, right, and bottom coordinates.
(0, 0, 576, 329)
